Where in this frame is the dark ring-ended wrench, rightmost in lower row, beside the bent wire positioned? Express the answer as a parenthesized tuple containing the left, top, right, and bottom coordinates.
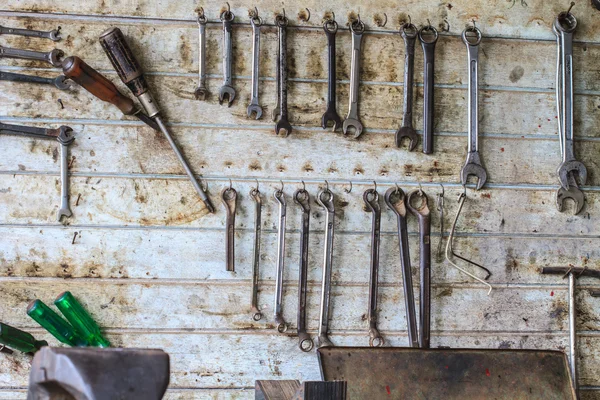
(406, 189, 431, 349)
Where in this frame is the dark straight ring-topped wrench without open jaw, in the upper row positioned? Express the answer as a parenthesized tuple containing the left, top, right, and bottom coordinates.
(419, 25, 438, 154)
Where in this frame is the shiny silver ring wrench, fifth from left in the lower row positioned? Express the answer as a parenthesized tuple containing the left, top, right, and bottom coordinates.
(317, 188, 335, 347)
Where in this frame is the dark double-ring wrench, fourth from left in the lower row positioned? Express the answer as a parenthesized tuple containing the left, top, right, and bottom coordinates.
(294, 188, 314, 352)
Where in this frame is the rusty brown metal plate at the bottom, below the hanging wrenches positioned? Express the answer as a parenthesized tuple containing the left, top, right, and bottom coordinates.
(317, 347, 575, 400)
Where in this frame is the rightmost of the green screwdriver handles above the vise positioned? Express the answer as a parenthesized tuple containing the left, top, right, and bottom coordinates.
(54, 292, 110, 347)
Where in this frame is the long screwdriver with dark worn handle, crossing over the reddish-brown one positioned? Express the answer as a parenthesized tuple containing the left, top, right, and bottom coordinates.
(100, 28, 215, 213)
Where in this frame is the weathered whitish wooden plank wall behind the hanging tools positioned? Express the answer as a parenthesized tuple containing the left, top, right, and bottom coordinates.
(0, 0, 600, 399)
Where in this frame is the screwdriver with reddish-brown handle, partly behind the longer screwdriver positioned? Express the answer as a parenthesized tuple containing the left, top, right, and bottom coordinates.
(62, 56, 160, 131)
